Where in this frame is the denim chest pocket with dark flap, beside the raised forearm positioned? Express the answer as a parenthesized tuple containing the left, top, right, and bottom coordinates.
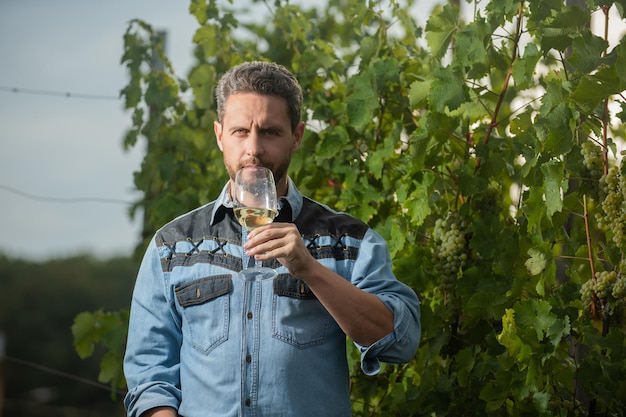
(272, 274, 331, 349)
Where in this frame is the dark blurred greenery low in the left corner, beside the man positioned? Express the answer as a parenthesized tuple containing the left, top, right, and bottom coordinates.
(0, 255, 137, 417)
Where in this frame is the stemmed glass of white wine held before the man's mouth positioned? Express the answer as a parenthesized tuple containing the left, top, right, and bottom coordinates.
(233, 166, 278, 281)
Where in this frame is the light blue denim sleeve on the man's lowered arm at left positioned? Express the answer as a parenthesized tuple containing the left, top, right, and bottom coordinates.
(124, 240, 182, 417)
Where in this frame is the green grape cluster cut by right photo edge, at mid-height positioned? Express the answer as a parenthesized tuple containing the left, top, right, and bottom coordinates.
(596, 162, 626, 249)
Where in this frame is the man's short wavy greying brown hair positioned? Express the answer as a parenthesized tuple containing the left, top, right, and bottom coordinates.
(215, 61, 302, 131)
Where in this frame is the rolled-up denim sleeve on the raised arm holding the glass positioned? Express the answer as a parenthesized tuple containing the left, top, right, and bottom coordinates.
(352, 229, 421, 375)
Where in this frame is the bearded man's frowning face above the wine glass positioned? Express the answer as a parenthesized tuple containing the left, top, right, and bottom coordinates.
(214, 93, 304, 195)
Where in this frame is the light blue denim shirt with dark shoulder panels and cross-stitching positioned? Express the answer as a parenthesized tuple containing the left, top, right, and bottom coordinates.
(124, 179, 420, 417)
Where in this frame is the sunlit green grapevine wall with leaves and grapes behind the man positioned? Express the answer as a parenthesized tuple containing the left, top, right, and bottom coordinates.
(75, 0, 626, 416)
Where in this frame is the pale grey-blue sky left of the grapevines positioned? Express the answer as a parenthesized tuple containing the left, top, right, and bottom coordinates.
(0, 0, 620, 260)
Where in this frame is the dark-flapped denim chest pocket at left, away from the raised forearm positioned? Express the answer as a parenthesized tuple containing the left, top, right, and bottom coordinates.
(175, 275, 232, 354)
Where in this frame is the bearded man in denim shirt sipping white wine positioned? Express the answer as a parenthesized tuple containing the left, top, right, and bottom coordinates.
(124, 62, 420, 417)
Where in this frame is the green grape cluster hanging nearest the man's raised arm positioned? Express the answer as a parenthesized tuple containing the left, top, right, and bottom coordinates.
(433, 212, 467, 290)
